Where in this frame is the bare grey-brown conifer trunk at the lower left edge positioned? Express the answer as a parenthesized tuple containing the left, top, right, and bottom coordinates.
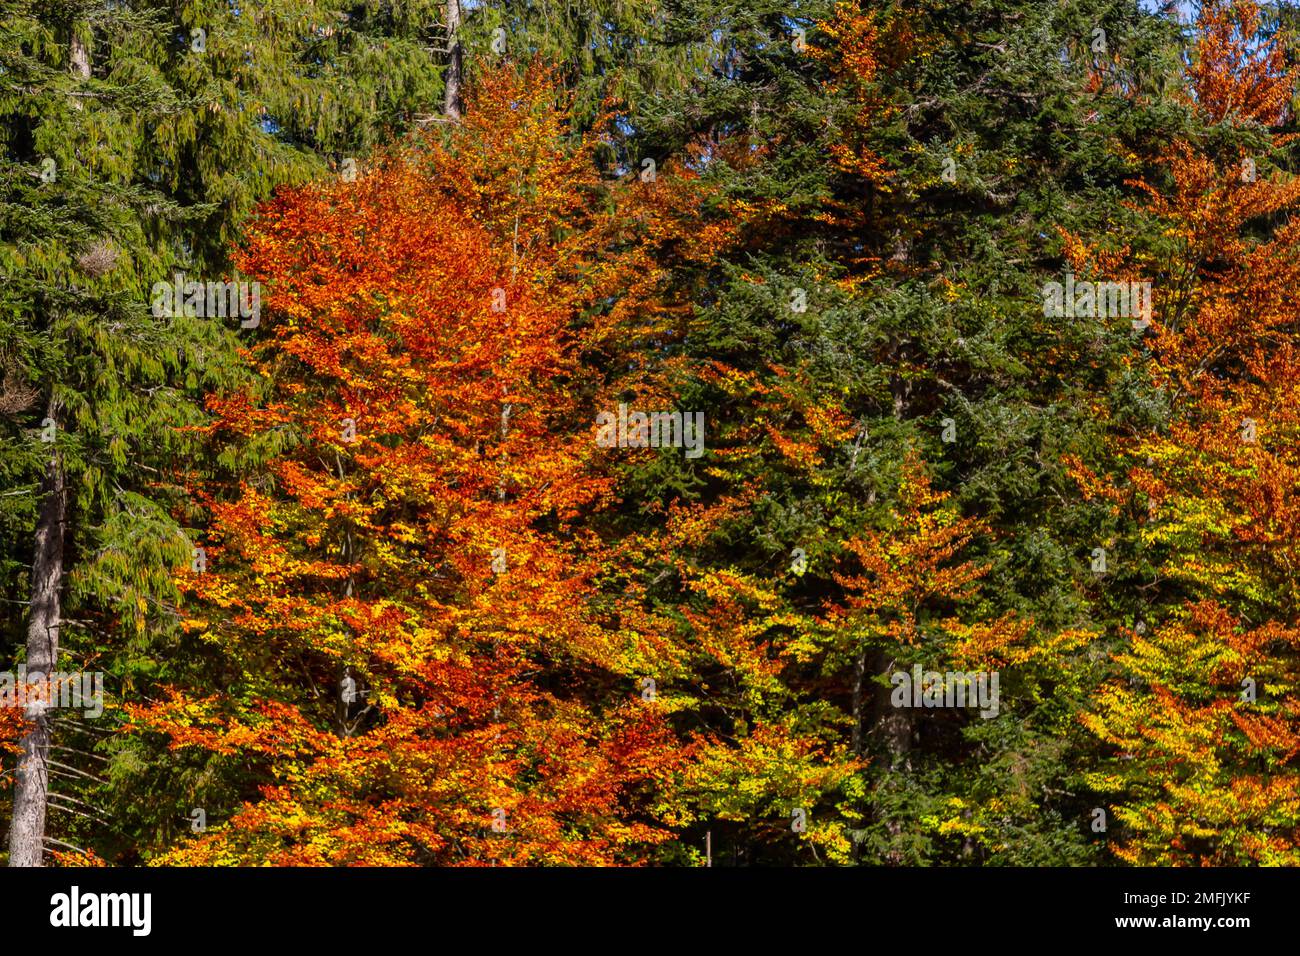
(9, 399, 68, 866)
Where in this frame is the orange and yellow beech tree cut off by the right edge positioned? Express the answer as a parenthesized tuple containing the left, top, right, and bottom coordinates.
(1086, 3, 1300, 865)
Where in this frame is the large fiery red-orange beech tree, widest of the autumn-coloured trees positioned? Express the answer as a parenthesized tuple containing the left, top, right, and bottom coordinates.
(131, 68, 725, 865)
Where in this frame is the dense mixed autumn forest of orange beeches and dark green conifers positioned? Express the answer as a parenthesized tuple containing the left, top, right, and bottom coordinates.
(0, 0, 1300, 866)
